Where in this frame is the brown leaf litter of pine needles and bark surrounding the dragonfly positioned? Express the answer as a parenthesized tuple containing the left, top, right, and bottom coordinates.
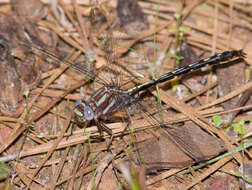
(0, 0, 251, 189)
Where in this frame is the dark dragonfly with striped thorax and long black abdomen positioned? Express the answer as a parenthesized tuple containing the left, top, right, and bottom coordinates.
(23, 43, 246, 147)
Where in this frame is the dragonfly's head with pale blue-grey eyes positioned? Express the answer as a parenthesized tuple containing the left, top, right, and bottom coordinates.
(74, 100, 94, 123)
